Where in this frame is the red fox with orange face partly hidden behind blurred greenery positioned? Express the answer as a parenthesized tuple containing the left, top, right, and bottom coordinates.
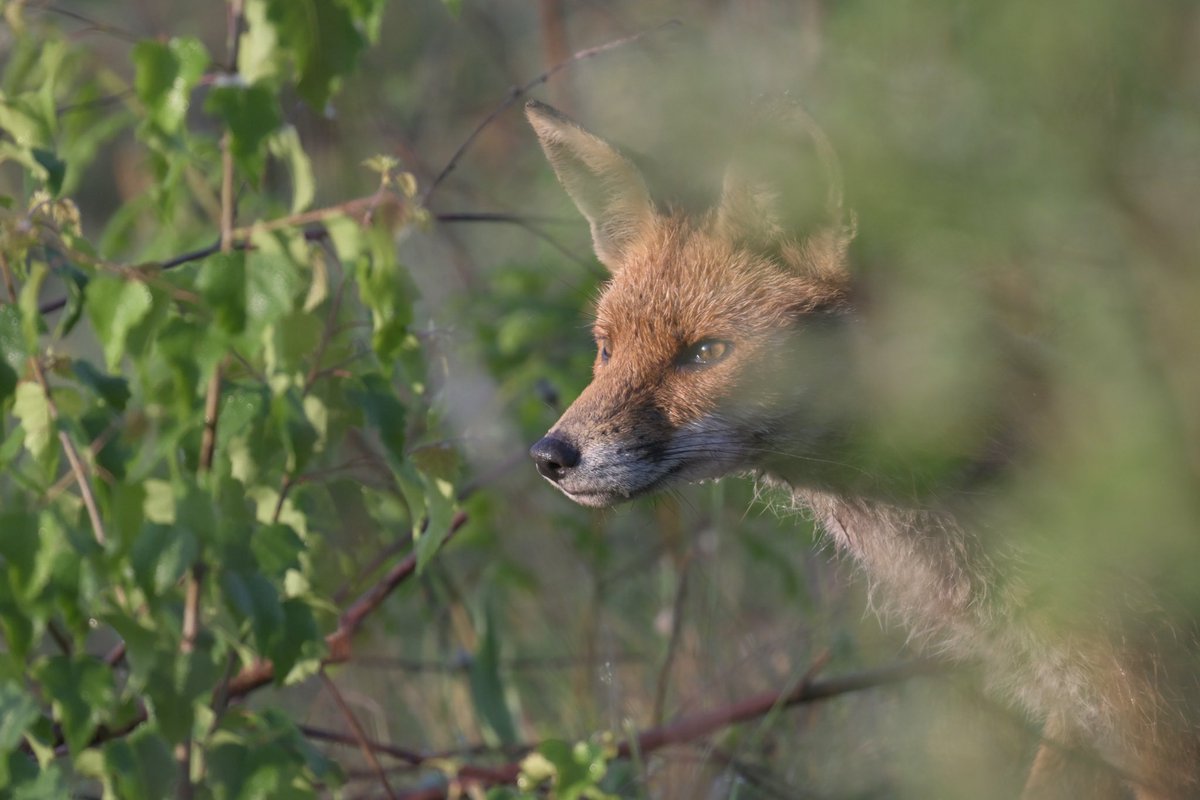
(526, 101, 1200, 800)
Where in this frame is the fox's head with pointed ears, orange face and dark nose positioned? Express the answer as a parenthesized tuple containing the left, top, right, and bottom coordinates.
(526, 102, 852, 506)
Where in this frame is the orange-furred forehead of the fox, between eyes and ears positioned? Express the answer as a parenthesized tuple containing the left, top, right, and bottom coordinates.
(595, 221, 805, 347)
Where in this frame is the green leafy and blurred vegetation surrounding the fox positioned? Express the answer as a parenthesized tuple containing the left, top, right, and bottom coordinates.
(0, 0, 1200, 798)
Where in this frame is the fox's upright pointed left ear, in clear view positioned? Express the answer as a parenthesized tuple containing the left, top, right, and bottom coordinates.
(526, 101, 654, 272)
